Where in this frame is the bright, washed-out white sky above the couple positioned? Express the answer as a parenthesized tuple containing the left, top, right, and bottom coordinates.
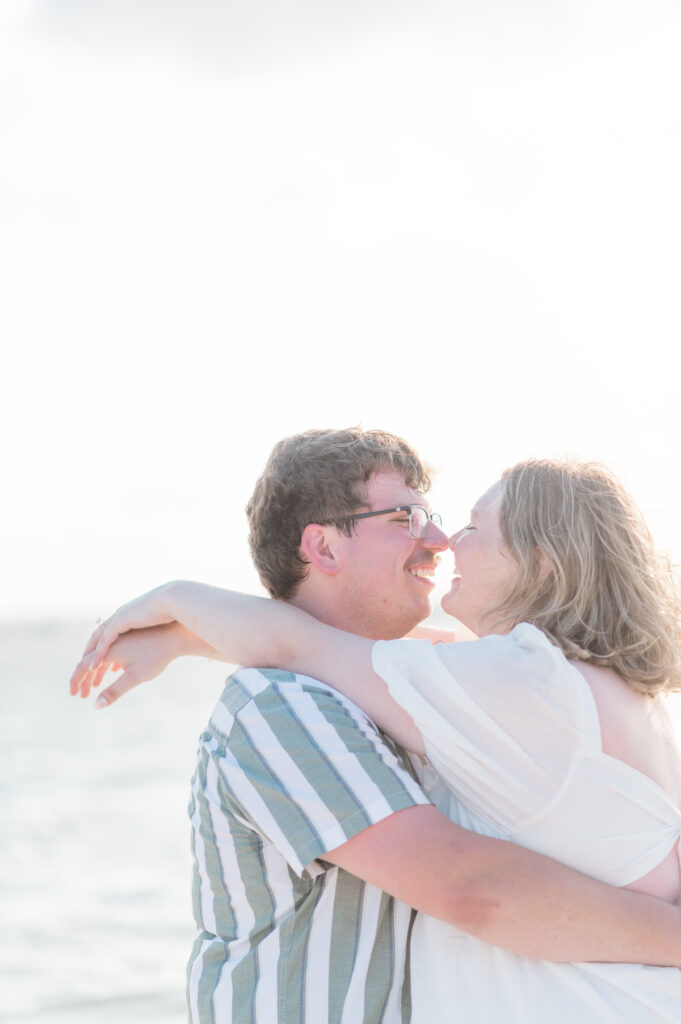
(0, 0, 681, 618)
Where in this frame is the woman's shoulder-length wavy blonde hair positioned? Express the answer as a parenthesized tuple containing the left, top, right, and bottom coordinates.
(491, 460, 681, 696)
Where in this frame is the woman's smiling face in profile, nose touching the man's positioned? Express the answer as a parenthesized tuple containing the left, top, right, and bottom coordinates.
(441, 483, 516, 636)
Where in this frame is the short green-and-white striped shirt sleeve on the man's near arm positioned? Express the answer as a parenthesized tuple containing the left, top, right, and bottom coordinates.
(213, 673, 429, 874)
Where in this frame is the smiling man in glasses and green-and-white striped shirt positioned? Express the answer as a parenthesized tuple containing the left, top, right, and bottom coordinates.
(76, 430, 681, 1024)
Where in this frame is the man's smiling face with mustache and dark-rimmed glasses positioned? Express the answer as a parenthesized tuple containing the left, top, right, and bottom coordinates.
(329, 472, 448, 639)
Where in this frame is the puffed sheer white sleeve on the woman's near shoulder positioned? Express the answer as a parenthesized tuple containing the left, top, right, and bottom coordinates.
(373, 623, 594, 833)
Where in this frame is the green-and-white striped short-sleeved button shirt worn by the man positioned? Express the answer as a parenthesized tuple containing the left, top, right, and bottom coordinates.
(187, 669, 428, 1024)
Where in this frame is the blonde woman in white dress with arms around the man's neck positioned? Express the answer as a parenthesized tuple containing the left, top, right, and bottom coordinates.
(73, 462, 681, 1024)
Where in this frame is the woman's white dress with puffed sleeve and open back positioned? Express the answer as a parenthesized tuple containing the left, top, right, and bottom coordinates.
(373, 623, 681, 1024)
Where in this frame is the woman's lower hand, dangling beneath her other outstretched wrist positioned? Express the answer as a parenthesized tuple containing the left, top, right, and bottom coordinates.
(71, 623, 215, 708)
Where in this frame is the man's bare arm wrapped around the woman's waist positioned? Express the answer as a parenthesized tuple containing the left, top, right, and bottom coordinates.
(325, 806, 681, 967)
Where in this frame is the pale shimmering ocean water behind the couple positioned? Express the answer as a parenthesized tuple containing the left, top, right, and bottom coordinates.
(0, 624, 681, 1024)
